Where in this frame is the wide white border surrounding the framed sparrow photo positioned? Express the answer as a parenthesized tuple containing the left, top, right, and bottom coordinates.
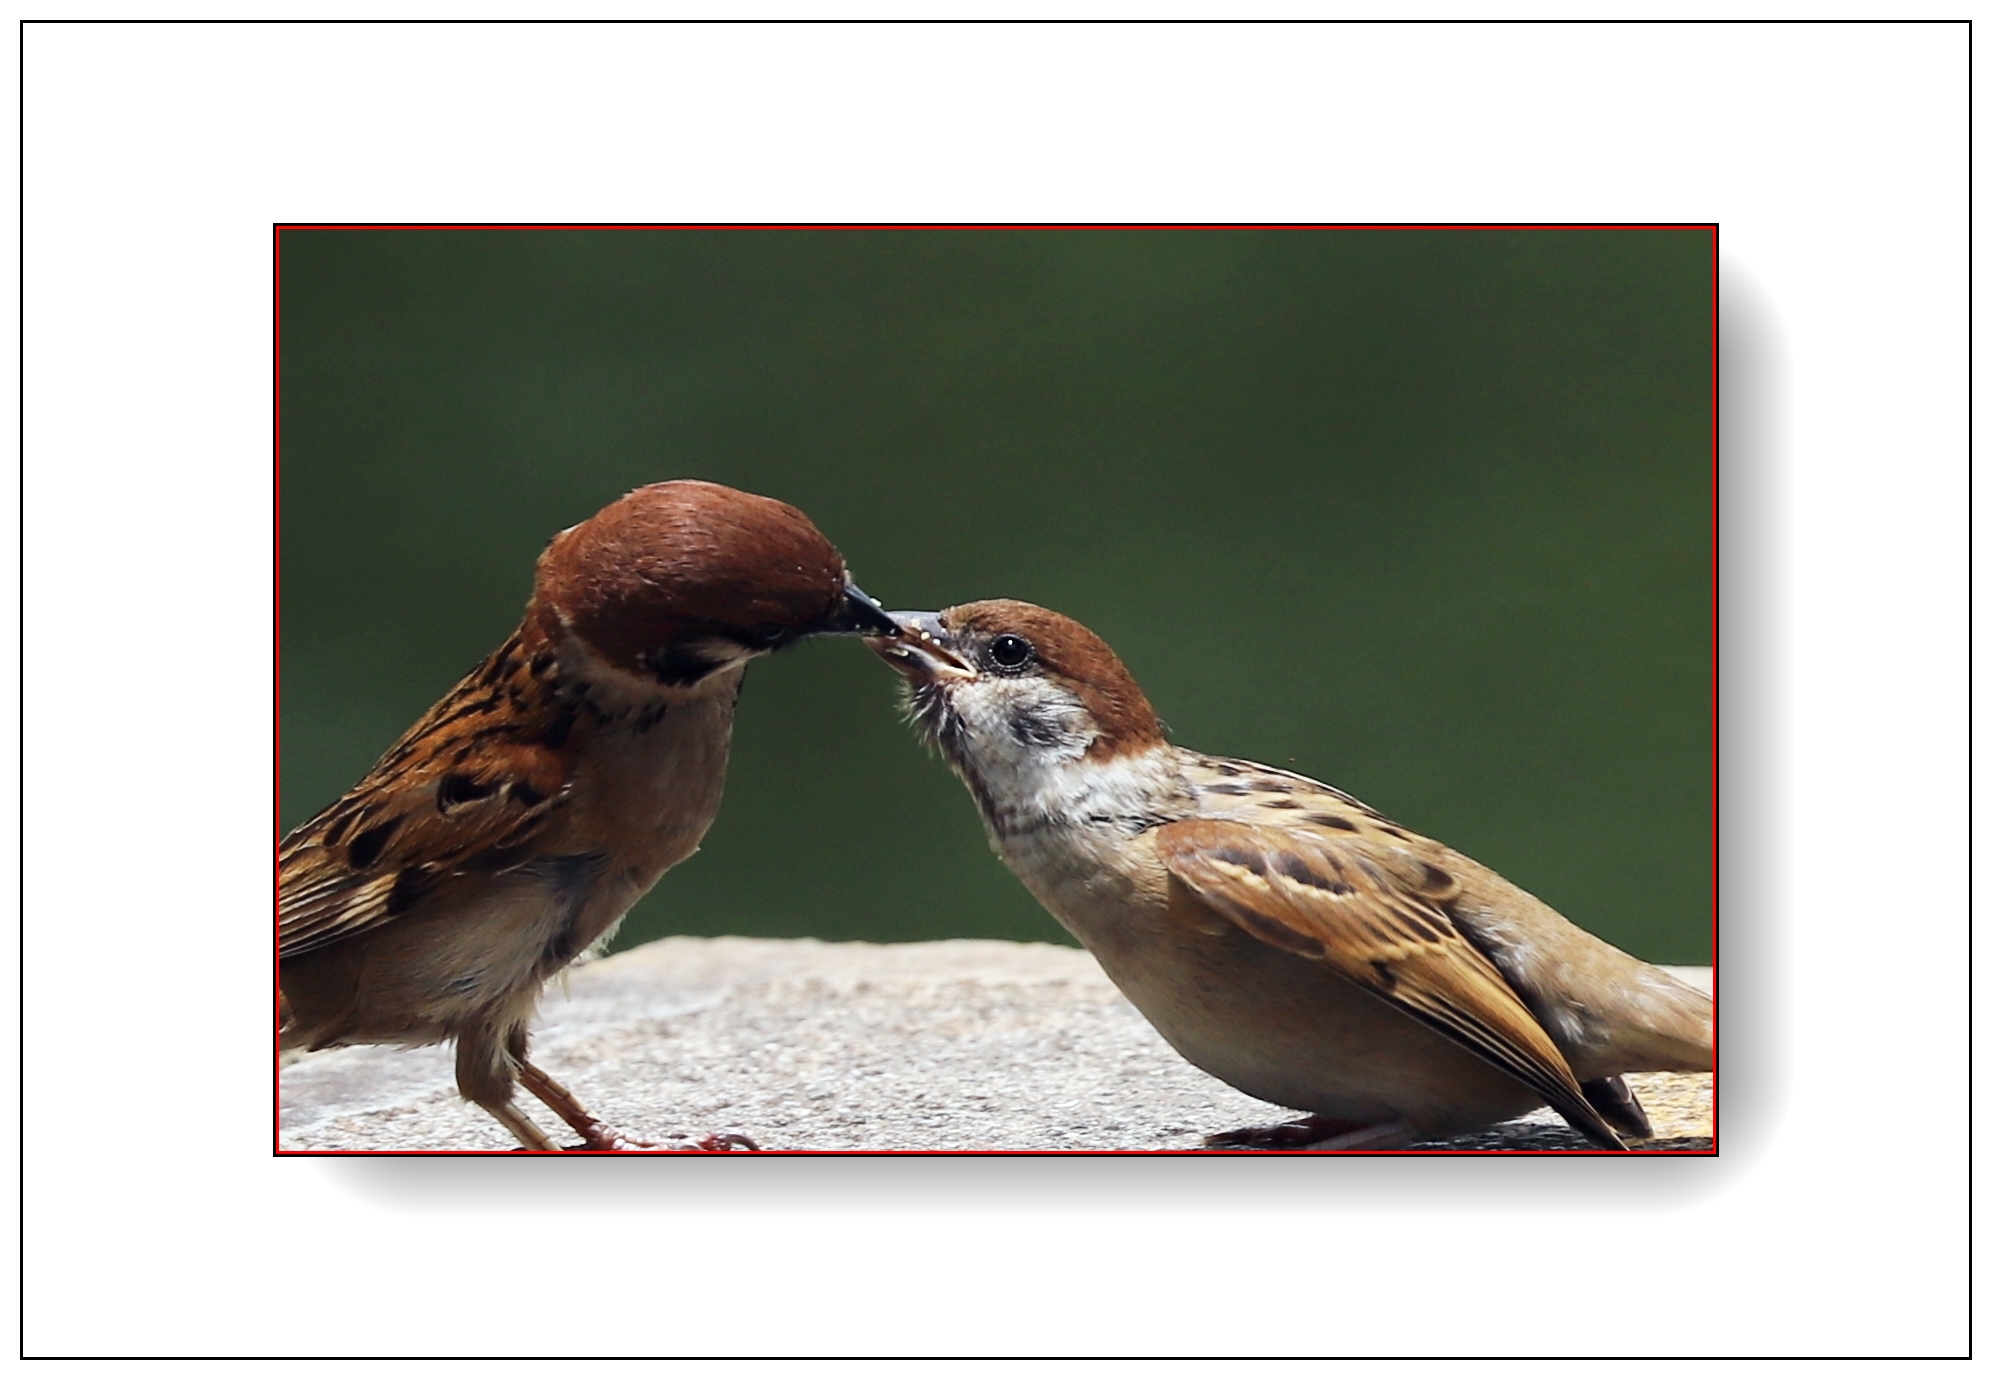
(15, 24, 1970, 1370)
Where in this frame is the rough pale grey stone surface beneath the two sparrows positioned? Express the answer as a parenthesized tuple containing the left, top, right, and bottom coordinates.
(277, 938, 1713, 1151)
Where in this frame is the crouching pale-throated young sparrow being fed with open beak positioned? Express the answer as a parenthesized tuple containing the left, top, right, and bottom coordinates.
(867, 599, 1713, 1149)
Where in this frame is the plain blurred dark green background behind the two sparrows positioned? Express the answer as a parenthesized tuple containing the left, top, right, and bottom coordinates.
(279, 231, 1713, 962)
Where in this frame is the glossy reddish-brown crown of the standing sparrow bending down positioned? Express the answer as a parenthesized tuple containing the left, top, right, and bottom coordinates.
(528, 480, 847, 669)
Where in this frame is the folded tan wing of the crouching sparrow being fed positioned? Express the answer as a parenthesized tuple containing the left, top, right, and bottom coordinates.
(1155, 818, 1623, 1149)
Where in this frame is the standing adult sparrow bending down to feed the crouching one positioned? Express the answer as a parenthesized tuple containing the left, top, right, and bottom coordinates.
(277, 480, 894, 1151)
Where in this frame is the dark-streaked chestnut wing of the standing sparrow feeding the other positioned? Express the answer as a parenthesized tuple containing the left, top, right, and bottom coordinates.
(277, 635, 574, 958)
